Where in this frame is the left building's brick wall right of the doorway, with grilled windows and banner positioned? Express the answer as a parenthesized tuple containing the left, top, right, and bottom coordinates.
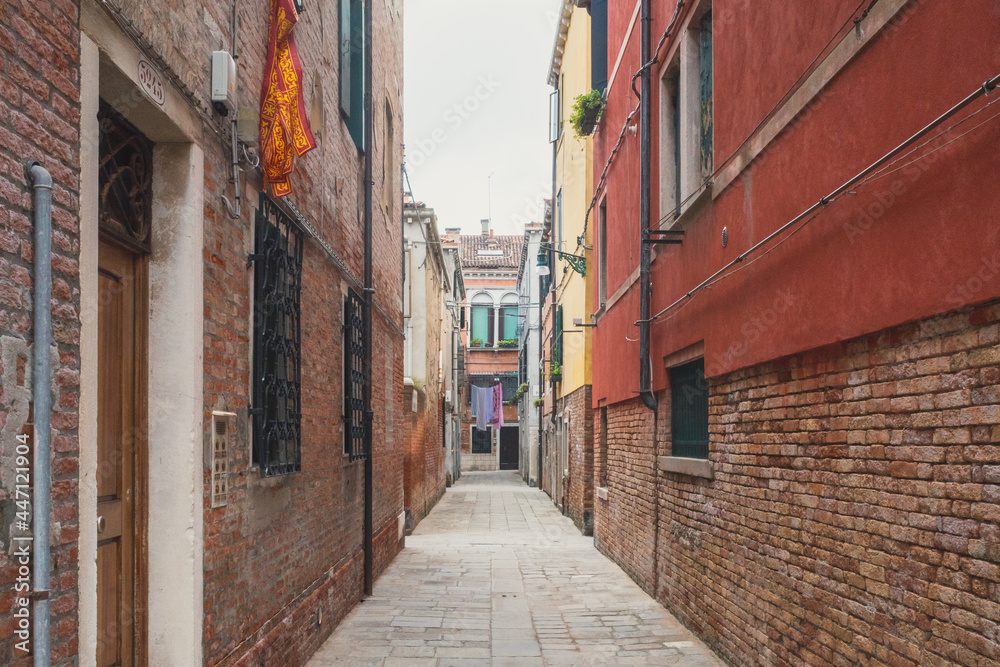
(59, 0, 403, 665)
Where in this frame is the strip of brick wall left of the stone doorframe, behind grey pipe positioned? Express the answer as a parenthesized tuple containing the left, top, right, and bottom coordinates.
(0, 0, 80, 665)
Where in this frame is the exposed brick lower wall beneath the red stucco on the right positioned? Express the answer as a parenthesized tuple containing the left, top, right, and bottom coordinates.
(595, 302, 1000, 666)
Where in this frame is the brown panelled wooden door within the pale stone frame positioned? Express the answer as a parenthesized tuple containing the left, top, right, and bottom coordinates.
(96, 240, 146, 667)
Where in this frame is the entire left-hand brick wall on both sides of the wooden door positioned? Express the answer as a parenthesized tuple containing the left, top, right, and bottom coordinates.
(0, 0, 405, 665)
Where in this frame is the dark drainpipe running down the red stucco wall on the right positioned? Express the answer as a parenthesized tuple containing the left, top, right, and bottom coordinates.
(639, 0, 657, 412)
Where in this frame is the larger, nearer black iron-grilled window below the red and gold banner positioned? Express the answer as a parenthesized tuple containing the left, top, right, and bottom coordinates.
(250, 194, 303, 477)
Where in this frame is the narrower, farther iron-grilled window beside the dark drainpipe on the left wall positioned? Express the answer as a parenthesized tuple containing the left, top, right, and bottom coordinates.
(344, 290, 368, 461)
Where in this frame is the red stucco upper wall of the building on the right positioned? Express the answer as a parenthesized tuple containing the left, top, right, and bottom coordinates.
(594, 0, 1000, 404)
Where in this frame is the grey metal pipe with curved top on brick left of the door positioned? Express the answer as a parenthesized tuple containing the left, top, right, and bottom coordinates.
(25, 160, 52, 667)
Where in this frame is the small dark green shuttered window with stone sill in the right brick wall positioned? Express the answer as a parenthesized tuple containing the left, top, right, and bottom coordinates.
(670, 359, 708, 459)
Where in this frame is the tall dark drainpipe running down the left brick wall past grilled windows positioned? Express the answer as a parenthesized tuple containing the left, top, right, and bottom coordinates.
(363, 1, 374, 595)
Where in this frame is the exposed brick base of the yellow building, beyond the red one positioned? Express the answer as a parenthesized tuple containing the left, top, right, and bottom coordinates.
(557, 385, 594, 535)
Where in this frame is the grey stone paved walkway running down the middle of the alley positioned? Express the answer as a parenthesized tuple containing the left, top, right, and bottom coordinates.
(308, 472, 723, 667)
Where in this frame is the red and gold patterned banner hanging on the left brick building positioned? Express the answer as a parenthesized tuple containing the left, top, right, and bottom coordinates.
(260, 0, 316, 197)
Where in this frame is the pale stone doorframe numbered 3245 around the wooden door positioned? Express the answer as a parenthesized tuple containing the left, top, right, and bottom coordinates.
(79, 0, 204, 667)
